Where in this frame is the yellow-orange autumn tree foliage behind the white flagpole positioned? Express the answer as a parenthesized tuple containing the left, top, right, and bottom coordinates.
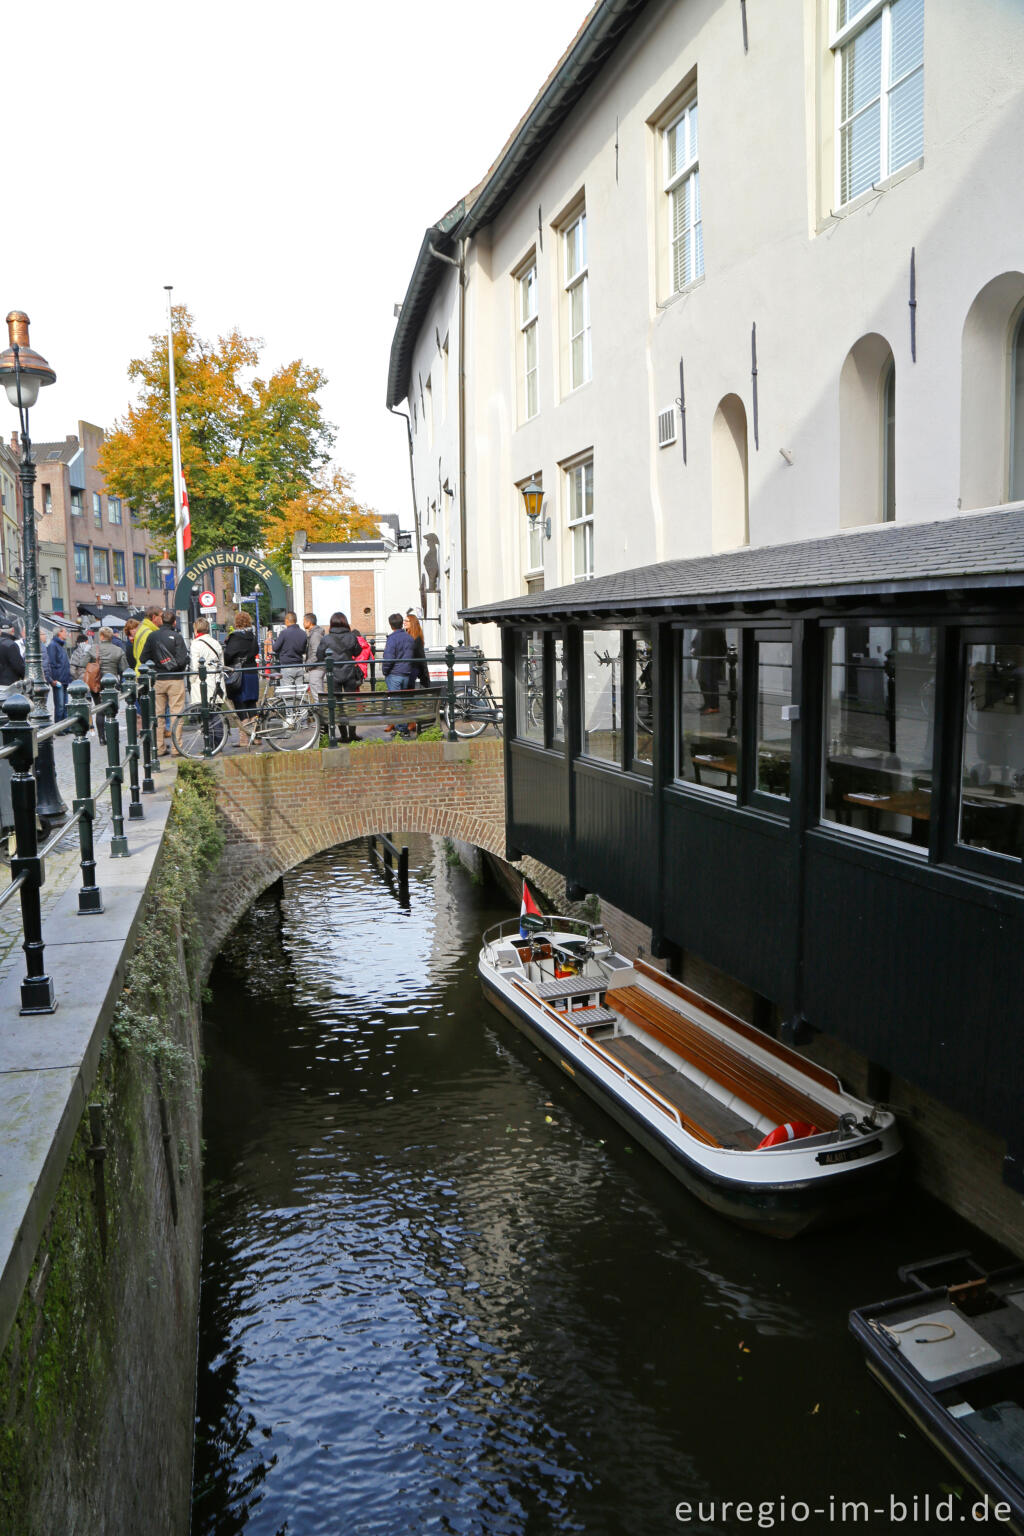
(100, 304, 368, 558)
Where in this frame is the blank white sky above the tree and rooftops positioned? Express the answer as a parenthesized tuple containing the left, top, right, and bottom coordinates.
(8, 0, 588, 527)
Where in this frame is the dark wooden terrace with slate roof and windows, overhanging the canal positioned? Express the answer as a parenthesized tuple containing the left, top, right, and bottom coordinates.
(465, 507, 1024, 1189)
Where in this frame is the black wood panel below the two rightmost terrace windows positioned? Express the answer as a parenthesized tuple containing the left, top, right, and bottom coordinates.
(804, 836, 1024, 1137)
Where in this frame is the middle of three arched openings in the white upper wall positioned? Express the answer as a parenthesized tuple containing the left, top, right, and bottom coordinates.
(840, 333, 897, 528)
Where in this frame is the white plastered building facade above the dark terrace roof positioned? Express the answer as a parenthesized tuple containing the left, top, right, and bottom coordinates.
(388, 0, 1024, 644)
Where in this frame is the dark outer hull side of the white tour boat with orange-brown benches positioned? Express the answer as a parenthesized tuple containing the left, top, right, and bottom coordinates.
(481, 966, 903, 1238)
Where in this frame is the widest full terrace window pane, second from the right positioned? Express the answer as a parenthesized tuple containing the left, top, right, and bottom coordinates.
(821, 624, 936, 846)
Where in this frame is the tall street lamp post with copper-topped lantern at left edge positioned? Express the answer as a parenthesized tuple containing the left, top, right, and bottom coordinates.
(0, 309, 68, 820)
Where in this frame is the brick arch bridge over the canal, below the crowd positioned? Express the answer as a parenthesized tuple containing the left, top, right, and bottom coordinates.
(203, 737, 505, 957)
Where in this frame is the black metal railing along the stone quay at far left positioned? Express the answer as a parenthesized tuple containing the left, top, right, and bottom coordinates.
(0, 668, 155, 1014)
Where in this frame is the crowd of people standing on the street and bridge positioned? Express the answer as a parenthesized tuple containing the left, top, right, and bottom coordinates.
(0, 607, 430, 756)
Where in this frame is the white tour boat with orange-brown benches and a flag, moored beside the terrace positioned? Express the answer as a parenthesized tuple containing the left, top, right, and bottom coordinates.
(479, 902, 901, 1236)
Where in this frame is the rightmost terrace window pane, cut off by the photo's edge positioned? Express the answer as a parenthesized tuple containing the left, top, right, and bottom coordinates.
(958, 645, 1024, 859)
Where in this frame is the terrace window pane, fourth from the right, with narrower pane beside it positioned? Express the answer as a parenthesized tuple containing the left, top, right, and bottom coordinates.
(679, 628, 740, 796)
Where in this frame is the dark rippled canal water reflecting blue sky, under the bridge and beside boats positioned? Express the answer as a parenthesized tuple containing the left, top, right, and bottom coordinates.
(192, 839, 1000, 1536)
